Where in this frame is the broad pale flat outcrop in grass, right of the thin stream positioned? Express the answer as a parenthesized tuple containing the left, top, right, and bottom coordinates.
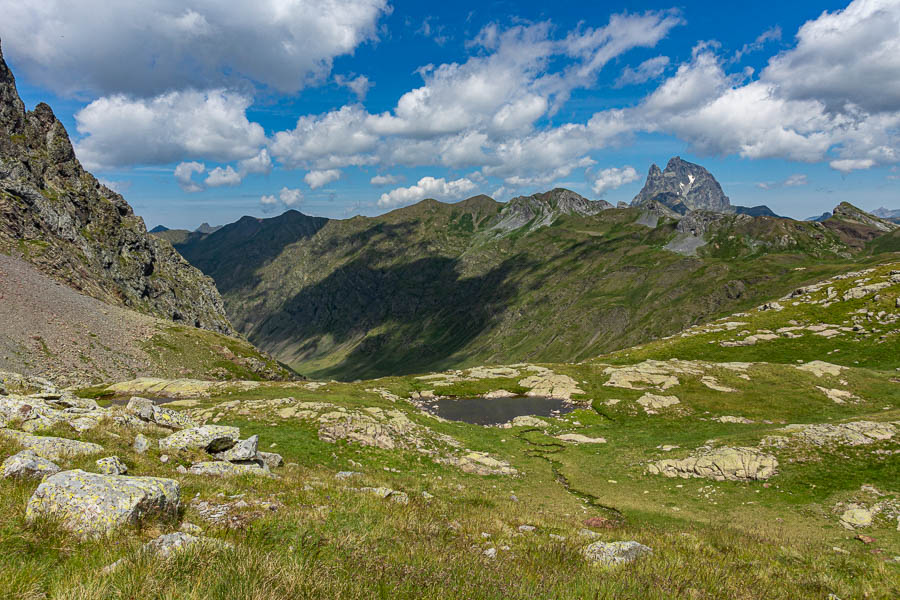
(648, 447, 778, 481)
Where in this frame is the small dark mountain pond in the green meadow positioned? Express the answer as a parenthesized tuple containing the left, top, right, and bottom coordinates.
(424, 396, 577, 425)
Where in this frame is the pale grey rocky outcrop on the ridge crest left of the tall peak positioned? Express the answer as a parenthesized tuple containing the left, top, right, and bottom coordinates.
(491, 188, 613, 233)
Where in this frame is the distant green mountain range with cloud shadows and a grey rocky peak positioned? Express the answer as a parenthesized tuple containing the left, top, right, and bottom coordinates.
(158, 164, 900, 379)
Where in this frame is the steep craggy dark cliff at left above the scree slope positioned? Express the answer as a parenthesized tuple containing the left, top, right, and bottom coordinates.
(0, 39, 233, 334)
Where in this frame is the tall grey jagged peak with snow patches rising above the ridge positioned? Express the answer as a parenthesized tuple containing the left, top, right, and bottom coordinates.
(631, 156, 734, 216)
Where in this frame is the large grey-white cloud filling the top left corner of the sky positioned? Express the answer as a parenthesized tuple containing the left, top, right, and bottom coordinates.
(0, 0, 390, 97)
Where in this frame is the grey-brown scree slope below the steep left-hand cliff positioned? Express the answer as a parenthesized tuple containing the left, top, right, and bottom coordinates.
(0, 253, 287, 385)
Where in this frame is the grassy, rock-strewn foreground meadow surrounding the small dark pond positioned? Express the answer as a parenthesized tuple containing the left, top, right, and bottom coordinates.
(0, 264, 900, 599)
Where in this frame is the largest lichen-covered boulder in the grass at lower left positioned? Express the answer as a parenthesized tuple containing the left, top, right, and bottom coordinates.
(25, 469, 181, 537)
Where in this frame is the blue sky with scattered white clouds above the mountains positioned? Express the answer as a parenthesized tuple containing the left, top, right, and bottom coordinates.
(0, 0, 900, 228)
